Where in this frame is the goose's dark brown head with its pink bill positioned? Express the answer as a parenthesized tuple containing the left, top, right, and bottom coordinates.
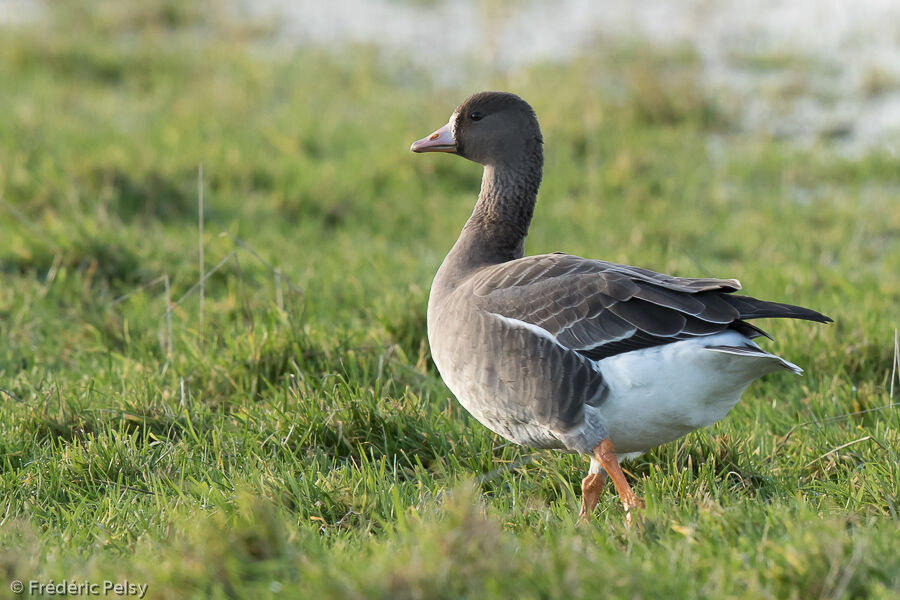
(410, 92, 543, 166)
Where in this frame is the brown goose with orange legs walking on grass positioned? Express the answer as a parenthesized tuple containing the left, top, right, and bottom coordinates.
(410, 92, 831, 519)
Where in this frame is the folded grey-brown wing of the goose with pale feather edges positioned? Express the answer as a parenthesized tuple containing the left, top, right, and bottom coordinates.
(472, 254, 831, 360)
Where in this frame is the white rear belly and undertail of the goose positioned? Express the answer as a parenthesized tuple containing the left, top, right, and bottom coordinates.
(587, 332, 799, 454)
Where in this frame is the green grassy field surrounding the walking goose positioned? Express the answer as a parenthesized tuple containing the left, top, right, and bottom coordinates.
(0, 2, 900, 599)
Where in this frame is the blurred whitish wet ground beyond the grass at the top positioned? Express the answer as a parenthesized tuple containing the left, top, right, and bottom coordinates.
(239, 0, 900, 151)
